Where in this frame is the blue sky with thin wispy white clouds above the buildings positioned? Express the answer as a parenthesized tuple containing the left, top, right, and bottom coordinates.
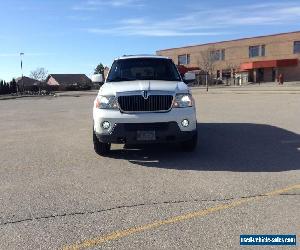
(0, 0, 300, 81)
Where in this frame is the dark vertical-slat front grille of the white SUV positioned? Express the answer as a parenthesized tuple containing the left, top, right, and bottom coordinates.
(118, 95, 173, 112)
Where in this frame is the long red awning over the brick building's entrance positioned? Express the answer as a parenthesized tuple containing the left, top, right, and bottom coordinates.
(240, 59, 298, 70)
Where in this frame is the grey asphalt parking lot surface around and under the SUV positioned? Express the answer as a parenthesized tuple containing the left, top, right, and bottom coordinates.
(0, 90, 300, 249)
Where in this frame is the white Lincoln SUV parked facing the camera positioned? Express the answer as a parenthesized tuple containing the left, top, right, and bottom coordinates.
(93, 56, 197, 155)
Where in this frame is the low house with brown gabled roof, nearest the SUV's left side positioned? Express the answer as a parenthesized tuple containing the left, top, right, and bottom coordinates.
(46, 74, 92, 90)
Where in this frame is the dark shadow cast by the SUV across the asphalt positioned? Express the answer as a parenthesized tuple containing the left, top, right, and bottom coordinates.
(109, 123, 300, 172)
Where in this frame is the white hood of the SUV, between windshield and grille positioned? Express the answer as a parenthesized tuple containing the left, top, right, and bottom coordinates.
(99, 80, 189, 95)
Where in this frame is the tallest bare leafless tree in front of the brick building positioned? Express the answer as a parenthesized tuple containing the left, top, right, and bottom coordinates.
(198, 47, 218, 91)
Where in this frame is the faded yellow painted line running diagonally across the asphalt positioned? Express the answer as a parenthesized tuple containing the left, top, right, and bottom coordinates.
(62, 184, 300, 250)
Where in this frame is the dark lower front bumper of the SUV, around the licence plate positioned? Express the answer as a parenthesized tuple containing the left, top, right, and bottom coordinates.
(96, 122, 197, 144)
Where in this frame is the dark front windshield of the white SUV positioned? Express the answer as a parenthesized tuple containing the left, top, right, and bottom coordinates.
(107, 58, 181, 82)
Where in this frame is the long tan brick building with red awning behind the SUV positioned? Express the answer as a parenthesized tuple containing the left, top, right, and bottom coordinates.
(156, 31, 300, 82)
